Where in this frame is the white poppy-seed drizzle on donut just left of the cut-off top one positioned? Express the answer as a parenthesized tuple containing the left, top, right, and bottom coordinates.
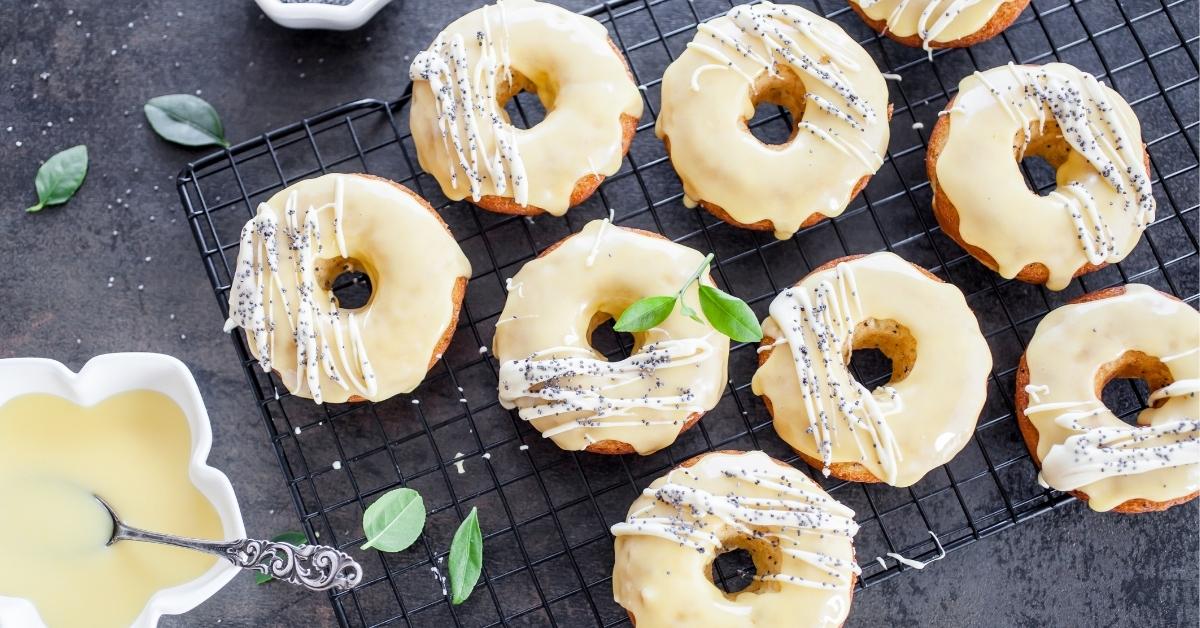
(688, 2, 883, 171)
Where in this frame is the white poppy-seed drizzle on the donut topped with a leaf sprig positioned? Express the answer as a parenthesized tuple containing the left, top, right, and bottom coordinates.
(499, 337, 713, 442)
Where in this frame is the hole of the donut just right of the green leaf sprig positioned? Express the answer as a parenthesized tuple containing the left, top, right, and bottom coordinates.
(845, 318, 917, 388)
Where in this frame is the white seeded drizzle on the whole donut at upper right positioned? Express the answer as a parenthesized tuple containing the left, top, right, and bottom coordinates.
(960, 62, 1154, 270)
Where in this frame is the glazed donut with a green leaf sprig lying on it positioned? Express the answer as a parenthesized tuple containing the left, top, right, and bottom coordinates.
(493, 220, 730, 454)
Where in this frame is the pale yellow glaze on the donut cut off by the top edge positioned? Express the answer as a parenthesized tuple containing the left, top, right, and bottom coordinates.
(851, 0, 1008, 50)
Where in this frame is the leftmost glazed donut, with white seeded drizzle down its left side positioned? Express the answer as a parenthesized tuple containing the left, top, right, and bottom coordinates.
(226, 174, 470, 403)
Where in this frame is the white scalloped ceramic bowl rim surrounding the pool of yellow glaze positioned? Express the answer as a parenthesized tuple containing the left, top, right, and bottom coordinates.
(0, 353, 246, 628)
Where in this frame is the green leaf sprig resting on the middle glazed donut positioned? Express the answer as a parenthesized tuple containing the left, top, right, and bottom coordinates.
(613, 253, 762, 342)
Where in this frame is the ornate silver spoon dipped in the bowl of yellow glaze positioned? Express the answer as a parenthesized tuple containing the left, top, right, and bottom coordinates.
(94, 495, 362, 591)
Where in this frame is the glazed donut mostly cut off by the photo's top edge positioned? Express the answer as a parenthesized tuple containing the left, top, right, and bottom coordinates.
(850, 0, 1030, 53)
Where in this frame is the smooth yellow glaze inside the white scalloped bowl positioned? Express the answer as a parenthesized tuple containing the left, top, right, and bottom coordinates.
(0, 390, 222, 628)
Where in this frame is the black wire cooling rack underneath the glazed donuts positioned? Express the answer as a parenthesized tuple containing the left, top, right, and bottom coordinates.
(178, 0, 1200, 627)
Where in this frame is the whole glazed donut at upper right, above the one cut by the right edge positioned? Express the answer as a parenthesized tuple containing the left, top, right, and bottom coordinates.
(925, 64, 1154, 289)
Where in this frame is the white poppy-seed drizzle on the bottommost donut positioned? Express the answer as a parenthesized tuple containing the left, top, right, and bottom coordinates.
(611, 453, 862, 590)
